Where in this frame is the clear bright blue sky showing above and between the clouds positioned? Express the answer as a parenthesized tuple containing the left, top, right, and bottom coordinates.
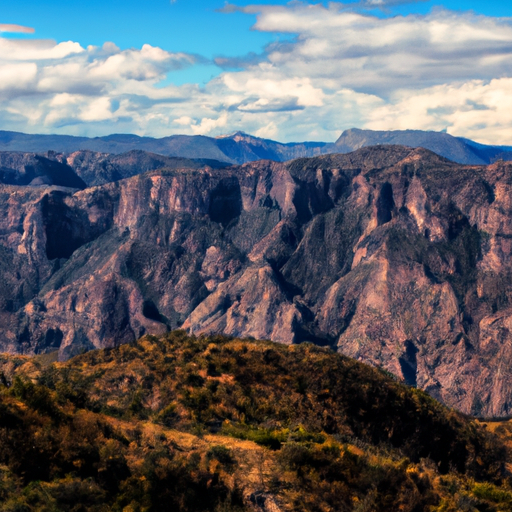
(4, 0, 512, 83)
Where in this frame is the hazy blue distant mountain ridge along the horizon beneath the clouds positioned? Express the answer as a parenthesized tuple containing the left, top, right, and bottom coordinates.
(0, 128, 512, 165)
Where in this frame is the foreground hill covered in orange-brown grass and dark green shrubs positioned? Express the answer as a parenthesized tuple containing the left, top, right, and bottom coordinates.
(0, 332, 512, 512)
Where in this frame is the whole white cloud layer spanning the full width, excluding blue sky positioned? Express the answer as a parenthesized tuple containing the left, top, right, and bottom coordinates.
(0, 0, 512, 144)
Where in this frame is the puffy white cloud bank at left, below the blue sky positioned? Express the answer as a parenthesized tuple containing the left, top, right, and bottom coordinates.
(0, 37, 198, 134)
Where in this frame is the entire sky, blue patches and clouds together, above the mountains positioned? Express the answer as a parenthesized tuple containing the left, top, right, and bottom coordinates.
(0, 0, 512, 145)
